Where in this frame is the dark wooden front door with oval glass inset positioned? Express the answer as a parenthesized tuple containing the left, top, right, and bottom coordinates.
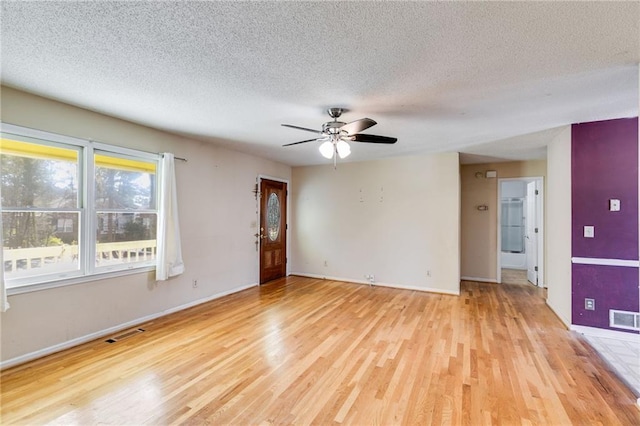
(258, 179, 287, 284)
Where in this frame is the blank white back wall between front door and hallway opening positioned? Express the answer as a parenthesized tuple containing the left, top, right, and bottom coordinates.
(291, 153, 460, 294)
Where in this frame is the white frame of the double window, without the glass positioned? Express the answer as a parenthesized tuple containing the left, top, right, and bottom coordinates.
(0, 122, 162, 295)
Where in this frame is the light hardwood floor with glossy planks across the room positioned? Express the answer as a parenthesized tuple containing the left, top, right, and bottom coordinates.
(1, 277, 640, 425)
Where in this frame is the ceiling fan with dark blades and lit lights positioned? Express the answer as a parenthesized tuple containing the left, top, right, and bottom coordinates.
(282, 108, 398, 166)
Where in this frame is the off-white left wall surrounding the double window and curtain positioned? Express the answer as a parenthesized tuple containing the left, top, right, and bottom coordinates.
(0, 87, 291, 366)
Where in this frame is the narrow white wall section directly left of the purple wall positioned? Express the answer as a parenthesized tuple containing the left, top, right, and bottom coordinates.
(545, 126, 571, 327)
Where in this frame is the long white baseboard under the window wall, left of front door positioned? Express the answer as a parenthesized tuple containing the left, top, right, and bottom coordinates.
(0, 283, 258, 370)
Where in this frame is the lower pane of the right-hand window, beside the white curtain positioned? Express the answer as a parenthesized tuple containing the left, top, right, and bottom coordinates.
(96, 212, 156, 266)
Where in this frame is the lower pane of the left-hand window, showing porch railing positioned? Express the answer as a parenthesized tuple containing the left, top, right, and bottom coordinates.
(2, 211, 80, 279)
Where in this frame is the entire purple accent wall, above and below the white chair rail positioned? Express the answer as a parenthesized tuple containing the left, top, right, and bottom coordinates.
(571, 117, 640, 331)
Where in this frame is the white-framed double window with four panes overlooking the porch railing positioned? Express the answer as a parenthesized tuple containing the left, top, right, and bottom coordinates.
(0, 124, 159, 288)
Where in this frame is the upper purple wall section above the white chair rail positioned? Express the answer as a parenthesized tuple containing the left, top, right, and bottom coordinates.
(571, 118, 638, 260)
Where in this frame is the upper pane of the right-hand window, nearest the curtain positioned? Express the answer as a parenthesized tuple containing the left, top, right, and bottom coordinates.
(95, 153, 156, 210)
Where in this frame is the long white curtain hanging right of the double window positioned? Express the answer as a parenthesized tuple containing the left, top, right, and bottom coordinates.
(156, 153, 184, 281)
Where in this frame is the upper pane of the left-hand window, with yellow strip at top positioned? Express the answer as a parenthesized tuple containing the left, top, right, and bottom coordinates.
(0, 139, 78, 209)
